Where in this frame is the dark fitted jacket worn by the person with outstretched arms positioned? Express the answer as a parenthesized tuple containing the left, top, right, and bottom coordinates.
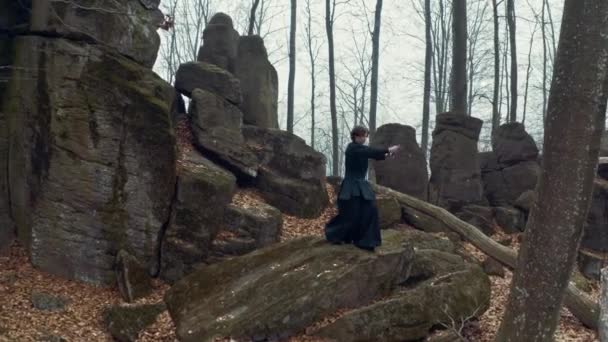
(338, 142, 388, 201)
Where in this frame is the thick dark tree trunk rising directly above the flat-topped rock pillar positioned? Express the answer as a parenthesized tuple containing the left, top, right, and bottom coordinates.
(450, 0, 467, 115)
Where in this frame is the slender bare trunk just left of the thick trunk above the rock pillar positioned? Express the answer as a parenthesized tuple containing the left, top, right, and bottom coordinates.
(421, 0, 433, 158)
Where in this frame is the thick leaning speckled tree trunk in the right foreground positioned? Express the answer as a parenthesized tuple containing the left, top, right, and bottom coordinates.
(495, 0, 608, 342)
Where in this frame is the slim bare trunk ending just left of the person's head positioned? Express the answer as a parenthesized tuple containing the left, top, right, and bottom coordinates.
(325, 0, 340, 176)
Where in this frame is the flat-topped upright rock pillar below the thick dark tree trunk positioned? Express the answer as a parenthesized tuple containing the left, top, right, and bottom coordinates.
(429, 113, 485, 211)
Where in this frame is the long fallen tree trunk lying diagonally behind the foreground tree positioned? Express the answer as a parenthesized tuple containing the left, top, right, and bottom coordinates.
(375, 186, 600, 330)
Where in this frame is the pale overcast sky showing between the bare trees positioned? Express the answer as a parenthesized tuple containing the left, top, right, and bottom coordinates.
(155, 0, 563, 152)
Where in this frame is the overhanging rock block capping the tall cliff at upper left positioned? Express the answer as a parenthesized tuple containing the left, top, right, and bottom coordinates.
(0, 0, 163, 68)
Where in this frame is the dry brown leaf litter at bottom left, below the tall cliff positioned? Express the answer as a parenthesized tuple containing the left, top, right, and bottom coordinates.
(0, 244, 175, 342)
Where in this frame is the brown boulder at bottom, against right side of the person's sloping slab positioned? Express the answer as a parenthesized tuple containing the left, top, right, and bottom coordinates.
(316, 249, 490, 342)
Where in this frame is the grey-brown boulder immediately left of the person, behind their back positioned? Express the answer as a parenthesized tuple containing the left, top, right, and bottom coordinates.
(243, 126, 329, 217)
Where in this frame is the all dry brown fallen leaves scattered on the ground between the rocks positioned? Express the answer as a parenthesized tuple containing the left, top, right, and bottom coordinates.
(0, 184, 598, 342)
